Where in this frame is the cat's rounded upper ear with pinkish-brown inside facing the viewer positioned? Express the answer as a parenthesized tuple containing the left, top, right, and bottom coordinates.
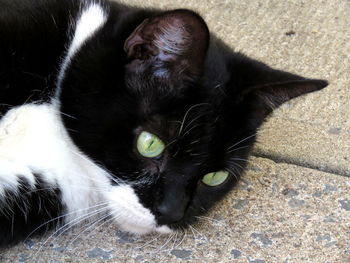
(124, 9, 209, 79)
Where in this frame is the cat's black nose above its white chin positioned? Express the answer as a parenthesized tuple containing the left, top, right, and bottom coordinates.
(157, 202, 185, 225)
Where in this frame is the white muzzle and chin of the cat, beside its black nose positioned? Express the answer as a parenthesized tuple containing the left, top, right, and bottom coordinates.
(106, 184, 173, 235)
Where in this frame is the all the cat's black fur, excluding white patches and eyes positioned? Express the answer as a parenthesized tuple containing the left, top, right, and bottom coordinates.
(0, 0, 327, 247)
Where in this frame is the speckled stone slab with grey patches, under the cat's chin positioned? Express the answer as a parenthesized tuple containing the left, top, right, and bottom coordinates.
(1, 157, 350, 263)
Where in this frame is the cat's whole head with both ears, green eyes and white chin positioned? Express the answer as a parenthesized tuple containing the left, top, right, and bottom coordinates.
(61, 6, 327, 233)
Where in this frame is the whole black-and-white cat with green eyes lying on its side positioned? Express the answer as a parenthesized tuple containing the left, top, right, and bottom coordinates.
(0, 0, 327, 247)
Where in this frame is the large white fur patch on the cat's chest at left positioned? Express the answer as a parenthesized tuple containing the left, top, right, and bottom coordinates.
(0, 104, 110, 220)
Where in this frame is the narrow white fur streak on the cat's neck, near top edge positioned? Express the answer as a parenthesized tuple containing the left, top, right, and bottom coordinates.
(56, 3, 107, 95)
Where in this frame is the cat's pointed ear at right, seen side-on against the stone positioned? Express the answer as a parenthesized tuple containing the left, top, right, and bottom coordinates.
(237, 63, 328, 121)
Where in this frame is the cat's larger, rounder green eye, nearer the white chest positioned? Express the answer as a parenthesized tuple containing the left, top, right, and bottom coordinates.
(137, 131, 165, 158)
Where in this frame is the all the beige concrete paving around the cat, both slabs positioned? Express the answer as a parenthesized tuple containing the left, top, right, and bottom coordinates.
(0, 0, 350, 263)
